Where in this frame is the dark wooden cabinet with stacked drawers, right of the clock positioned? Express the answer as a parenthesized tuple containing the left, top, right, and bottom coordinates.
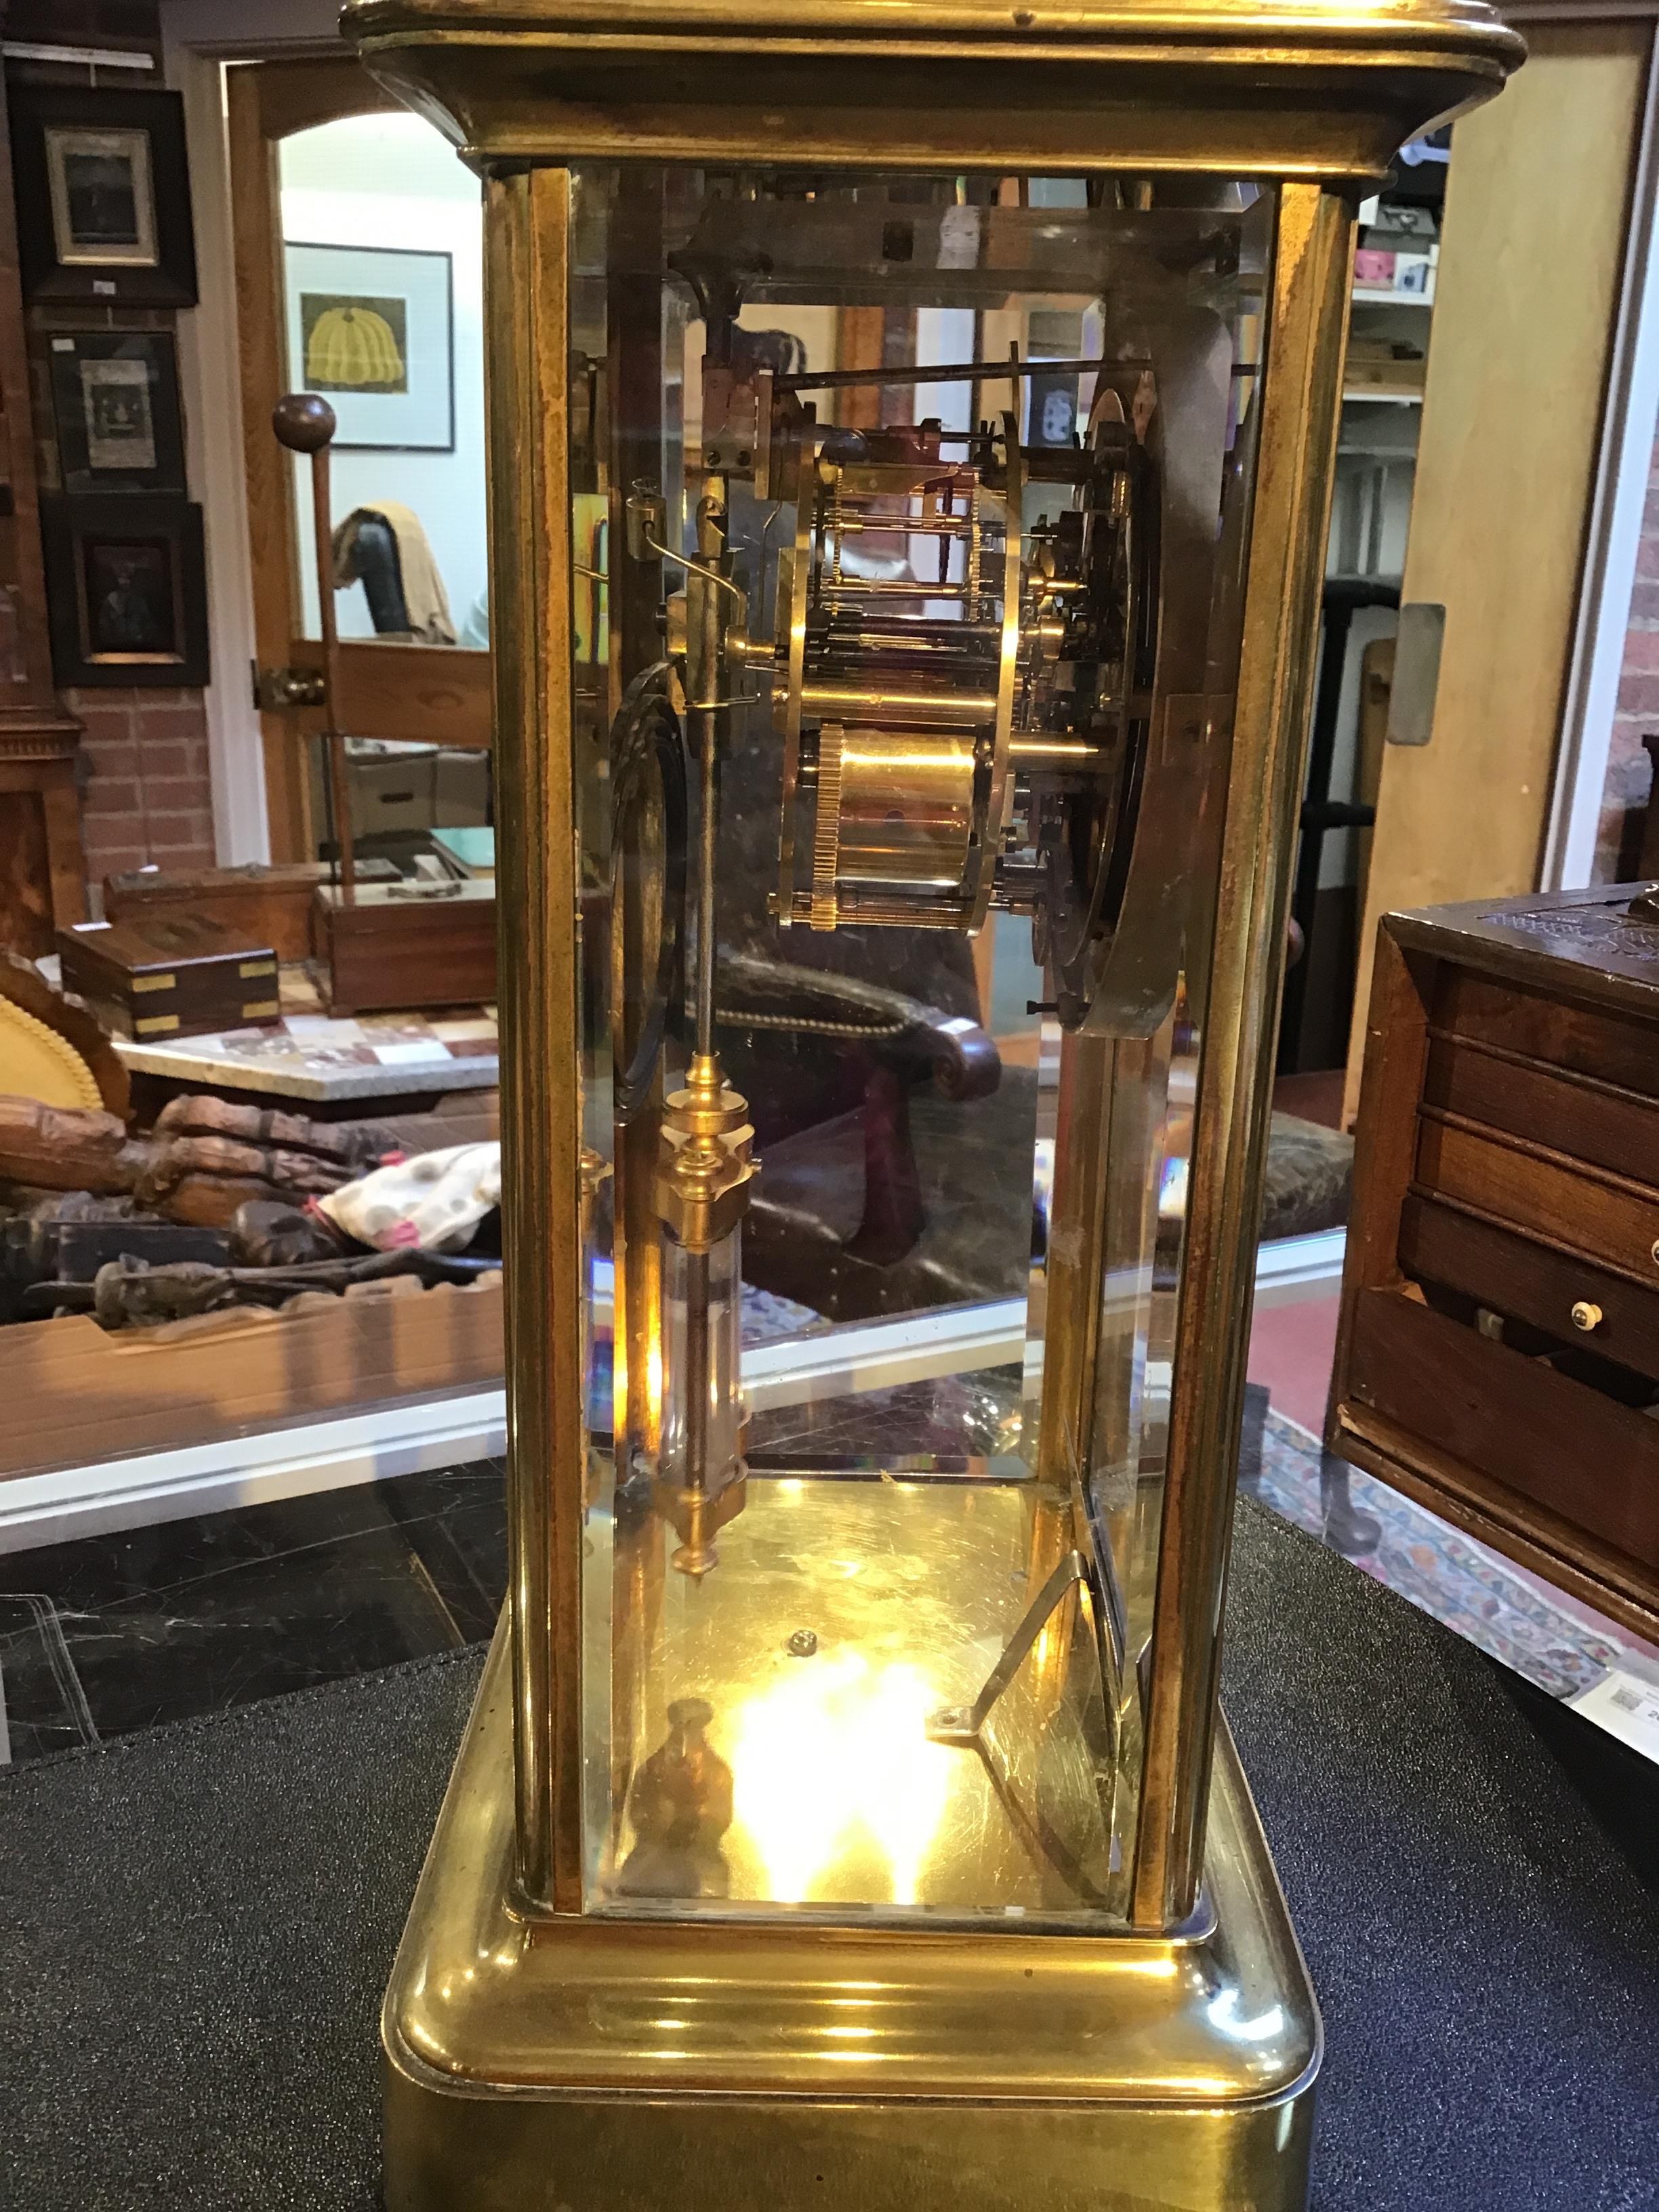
(1330, 885, 1659, 1635)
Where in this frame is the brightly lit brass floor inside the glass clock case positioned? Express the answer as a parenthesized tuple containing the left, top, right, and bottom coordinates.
(584, 1473, 1128, 1929)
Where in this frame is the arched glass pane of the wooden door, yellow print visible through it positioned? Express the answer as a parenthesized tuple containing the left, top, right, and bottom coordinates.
(276, 112, 489, 646)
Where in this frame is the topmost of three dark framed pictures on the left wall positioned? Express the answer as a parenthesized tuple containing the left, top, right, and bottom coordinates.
(11, 84, 197, 308)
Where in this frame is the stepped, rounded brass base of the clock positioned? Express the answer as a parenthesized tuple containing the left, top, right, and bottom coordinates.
(380, 1635, 1321, 2212)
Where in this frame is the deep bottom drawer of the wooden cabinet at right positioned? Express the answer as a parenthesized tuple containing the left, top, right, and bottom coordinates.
(1345, 1290, 1659, 1568)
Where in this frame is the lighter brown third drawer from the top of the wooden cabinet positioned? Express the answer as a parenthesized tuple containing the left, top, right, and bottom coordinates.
(1416, 1115, 1659, 1283)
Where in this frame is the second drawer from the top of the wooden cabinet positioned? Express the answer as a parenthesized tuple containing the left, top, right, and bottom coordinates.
(1422, 1038, 1659, 1183)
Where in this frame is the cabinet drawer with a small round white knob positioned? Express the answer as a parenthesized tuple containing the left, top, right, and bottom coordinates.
(1400, 1199, 1659, 1380)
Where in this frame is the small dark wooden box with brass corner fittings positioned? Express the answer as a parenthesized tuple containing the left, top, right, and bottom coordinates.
(58, 914, 281, 1038)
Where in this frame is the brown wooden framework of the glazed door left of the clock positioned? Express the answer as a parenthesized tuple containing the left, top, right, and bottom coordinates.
(228, 58, 491, 861)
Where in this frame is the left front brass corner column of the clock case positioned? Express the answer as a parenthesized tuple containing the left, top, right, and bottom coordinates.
(485, 168, 586, 1911)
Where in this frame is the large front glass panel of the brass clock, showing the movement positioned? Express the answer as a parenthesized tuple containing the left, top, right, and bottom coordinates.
(571, 168, 1272, 1925)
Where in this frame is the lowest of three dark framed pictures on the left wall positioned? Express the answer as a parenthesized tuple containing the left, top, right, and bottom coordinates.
(40, 491, 208, 686)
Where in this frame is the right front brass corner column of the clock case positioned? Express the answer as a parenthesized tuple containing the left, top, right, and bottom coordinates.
(1134, 184, 1354, 1929)
